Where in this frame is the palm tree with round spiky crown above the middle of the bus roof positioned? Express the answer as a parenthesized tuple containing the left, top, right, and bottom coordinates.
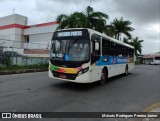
(110, 17, 134, 40)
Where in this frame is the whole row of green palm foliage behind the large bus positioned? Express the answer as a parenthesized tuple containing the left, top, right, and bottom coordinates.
(57, 6, 143, 55)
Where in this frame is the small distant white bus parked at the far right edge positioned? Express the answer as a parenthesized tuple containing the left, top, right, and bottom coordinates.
(143, 55, 160, 65)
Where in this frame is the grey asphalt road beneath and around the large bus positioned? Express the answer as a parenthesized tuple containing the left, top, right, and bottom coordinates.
(0, 65, 160, 120)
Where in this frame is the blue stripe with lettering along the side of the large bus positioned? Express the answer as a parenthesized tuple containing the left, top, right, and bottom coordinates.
(96, 56, 130, 66)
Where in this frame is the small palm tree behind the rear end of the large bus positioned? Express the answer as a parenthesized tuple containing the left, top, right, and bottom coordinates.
(123, 37, 143, 56)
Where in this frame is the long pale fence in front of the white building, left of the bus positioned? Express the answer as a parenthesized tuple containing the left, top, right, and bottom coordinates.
(0, 39, 50, 66)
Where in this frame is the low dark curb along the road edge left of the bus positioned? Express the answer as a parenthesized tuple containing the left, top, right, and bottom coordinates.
(0, 69, 48, 75)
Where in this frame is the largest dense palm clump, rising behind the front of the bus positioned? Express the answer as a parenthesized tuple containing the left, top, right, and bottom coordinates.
(57, 6, 108, 32)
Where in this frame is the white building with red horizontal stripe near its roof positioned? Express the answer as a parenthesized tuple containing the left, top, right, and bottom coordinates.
(0, 14, 58, 56)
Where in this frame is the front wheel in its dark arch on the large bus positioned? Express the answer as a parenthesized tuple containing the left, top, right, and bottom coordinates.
(99, 67, 108, 85)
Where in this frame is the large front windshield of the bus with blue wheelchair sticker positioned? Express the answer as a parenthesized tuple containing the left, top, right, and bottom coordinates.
(51, 39, 89, 61)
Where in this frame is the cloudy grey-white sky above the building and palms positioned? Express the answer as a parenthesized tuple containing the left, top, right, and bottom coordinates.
(0, 0, 160, 53)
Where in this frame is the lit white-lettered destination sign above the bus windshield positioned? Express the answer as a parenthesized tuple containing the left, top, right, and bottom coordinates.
(57, 31, 82, 37)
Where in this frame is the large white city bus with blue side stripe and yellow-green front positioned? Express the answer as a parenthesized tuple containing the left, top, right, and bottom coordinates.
(49, 28, 135, 84)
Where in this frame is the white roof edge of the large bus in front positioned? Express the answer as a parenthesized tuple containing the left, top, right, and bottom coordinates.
(57, 28, 134, 49)
